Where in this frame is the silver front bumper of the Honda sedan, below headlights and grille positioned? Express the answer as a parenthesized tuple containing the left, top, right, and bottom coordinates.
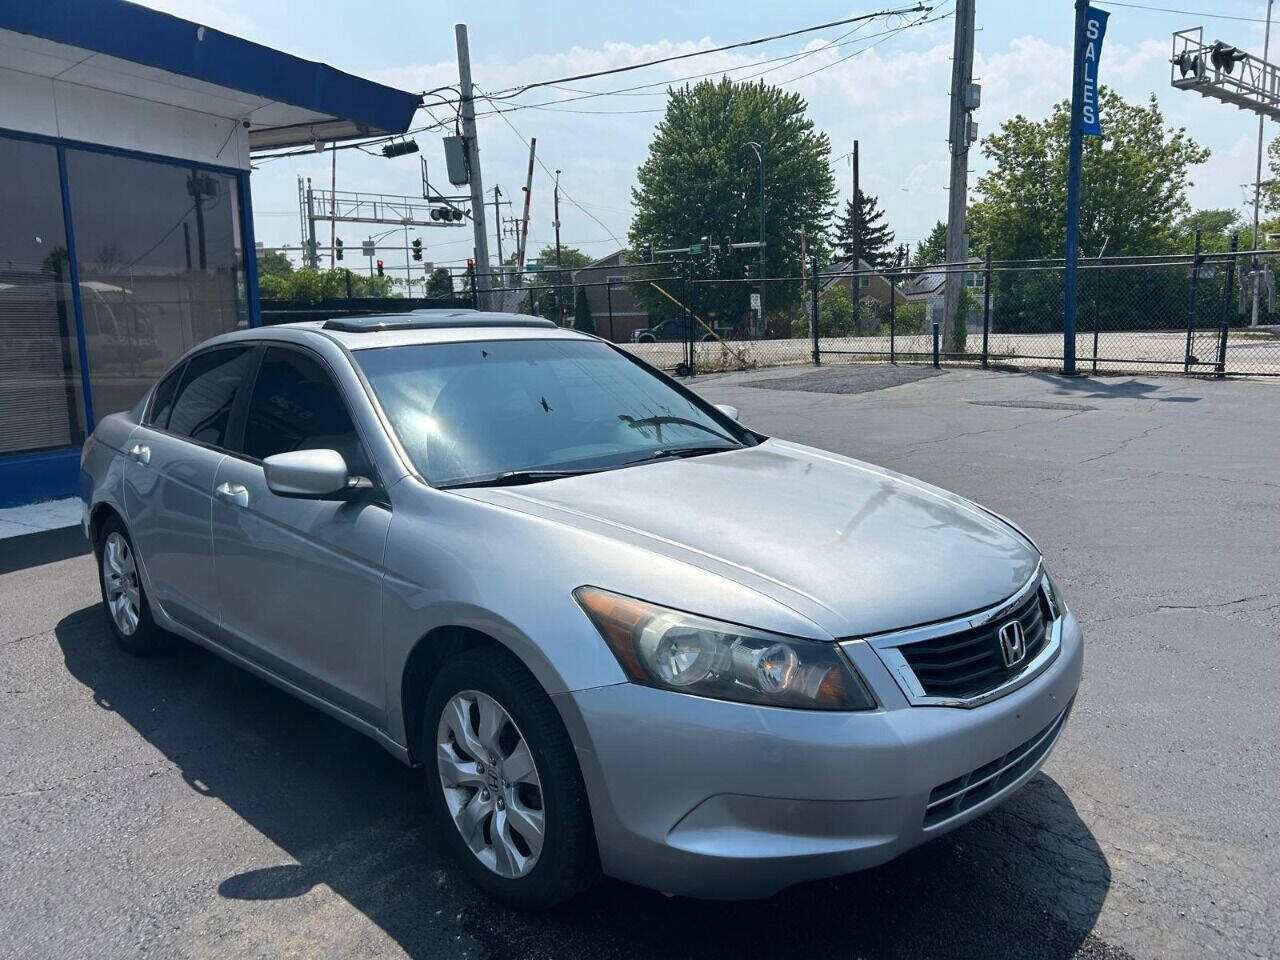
(556, 613, 1084, 899)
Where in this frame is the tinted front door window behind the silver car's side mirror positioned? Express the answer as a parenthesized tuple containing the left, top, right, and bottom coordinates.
(244, 347, 369, 475)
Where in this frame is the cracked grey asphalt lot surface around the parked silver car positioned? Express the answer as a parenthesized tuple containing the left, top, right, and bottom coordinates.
(0, 367, 1280, 960)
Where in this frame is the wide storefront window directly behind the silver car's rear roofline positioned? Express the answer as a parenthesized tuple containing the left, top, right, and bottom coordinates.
(67, 148, 248, 417)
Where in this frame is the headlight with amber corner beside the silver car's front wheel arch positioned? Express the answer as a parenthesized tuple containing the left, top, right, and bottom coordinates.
(573, 586, 876, 710)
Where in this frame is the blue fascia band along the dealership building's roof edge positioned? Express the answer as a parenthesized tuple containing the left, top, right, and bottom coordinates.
(0, 0, 420, 133)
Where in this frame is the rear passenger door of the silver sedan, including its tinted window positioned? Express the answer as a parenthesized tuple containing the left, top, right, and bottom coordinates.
(124, 346, 256, 636)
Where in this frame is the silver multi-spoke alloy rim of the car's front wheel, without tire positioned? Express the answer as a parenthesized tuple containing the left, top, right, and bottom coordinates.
(435, 690, 547, 879)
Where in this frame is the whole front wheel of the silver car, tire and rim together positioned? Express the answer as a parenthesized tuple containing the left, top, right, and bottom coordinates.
(421, 646, 600, 910)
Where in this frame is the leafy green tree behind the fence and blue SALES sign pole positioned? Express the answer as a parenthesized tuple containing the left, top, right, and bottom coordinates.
(969, 87, 1208, 333)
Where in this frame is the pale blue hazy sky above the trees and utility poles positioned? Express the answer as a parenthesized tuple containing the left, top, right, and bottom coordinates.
(146, 0, 1280, 271)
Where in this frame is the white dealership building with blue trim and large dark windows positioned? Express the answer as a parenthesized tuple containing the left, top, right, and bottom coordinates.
(0, 0, 419, 507)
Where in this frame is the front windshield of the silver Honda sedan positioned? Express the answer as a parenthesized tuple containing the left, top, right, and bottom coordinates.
(355, 339, 751, 486)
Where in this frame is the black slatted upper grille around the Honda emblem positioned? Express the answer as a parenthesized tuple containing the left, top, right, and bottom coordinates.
(897, 589, 1051, 699)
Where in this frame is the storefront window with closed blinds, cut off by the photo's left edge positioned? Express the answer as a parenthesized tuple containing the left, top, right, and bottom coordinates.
(0, 137, 84, 463)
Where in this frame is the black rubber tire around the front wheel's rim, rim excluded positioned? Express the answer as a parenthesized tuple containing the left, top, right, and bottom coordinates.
(421, 648, 598, 910)
